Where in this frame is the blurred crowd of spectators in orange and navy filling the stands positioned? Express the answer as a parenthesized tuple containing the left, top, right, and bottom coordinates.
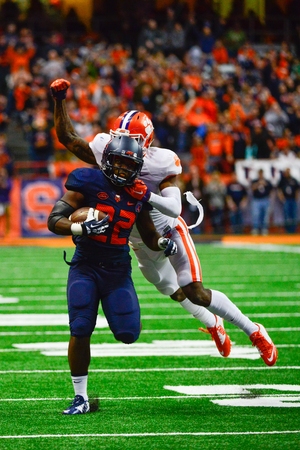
(0, 0, 300, 234)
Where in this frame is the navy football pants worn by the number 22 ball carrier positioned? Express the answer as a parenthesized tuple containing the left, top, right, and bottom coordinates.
(67, 263, 141, 344)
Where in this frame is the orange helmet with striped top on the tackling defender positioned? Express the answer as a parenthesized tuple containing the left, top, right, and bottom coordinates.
(110, 110, 154, 148)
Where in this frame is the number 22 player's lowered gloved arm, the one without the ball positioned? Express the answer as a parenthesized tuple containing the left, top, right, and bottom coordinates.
(136, 209, 177, 256)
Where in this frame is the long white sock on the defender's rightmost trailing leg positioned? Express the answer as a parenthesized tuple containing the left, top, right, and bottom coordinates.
(207, 289, 258, 336)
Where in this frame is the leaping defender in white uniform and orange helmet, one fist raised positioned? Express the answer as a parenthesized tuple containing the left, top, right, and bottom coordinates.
(50, 79, 277, 366)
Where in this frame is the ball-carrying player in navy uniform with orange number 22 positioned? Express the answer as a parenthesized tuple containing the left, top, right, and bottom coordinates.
(48, 136, 177, 415)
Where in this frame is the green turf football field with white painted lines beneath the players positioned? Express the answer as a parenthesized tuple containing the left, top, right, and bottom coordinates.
(0, 244, 300, 450)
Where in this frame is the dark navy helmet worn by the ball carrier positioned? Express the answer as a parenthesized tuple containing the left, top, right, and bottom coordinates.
(101, 136, 144, 187)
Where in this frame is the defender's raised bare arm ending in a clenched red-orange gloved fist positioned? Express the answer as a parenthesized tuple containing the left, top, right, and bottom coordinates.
(50, 79, 97, 165)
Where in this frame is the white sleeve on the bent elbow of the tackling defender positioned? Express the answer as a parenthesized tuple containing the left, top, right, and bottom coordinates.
(149, 186, 182, 218)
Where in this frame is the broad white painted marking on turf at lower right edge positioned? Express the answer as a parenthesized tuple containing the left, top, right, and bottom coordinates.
(164, 384, 300, 408)
